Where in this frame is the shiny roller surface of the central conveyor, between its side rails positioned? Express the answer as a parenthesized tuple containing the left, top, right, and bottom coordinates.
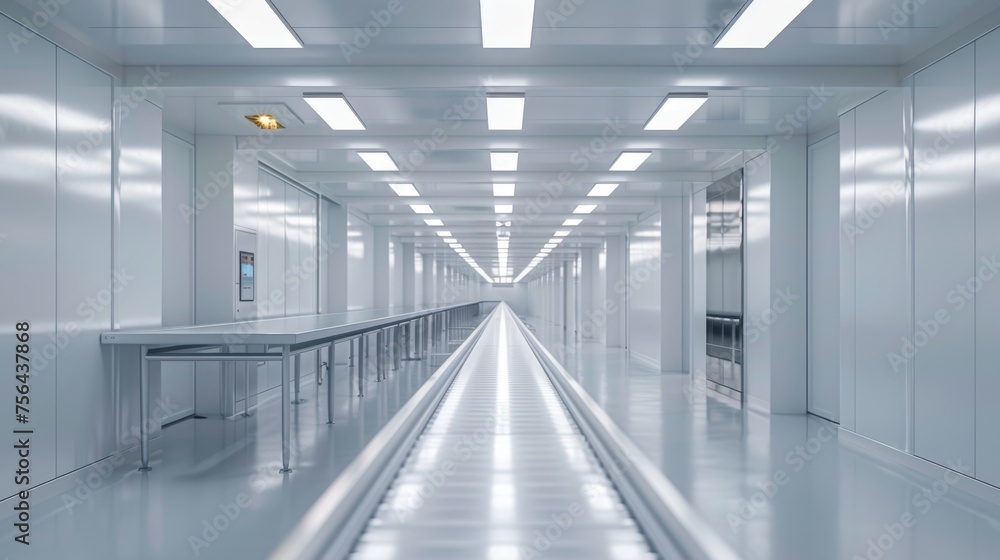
(351, 306, 655, 560)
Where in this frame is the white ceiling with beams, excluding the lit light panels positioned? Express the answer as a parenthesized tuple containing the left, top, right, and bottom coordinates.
(9, 0, 1000, 275)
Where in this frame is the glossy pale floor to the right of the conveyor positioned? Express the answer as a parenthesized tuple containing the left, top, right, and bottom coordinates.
(529, 320, 1000, 560)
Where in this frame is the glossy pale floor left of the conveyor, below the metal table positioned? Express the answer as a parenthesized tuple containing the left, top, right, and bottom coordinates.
(0, 342, 454, 560)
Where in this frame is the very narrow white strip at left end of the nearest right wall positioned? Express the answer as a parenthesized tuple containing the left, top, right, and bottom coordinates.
(837, 110, 857, 431)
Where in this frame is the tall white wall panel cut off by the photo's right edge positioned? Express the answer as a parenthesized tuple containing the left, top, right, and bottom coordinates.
(976, 31, 1000, 486)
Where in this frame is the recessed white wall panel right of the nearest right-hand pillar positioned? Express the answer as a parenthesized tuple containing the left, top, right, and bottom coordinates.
(808, 135, 840, 422)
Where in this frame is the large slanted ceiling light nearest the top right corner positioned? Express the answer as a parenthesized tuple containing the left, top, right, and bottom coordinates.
(715, 0, 812, 49)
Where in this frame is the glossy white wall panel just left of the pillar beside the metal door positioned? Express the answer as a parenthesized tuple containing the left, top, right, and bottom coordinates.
(622, 211, 662, 364)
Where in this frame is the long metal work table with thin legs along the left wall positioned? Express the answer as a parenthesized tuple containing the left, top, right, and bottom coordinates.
(101, 302, 489, 473)
